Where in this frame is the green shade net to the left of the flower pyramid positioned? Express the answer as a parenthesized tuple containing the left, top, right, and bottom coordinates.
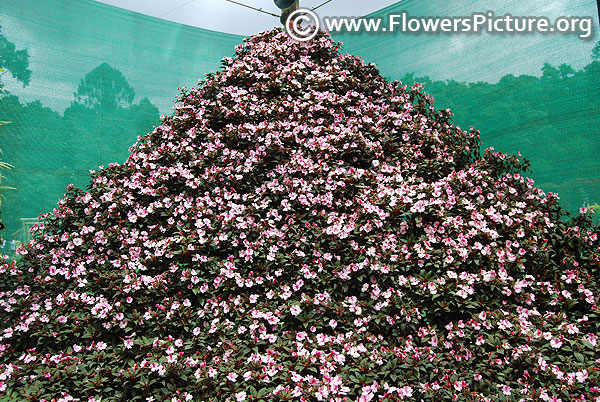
(0, 0, 242, 254)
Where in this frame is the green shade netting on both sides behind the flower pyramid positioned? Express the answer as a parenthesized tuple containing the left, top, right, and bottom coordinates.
(0, 0, 600, 254)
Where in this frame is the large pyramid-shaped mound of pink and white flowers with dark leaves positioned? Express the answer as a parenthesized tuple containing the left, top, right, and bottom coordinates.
(0, 30, 600, 402)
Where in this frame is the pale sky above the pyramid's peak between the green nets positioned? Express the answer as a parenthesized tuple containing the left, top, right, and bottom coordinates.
(96, 0, 399, 35)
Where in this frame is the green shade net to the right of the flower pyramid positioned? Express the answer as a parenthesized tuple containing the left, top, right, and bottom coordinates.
(335, 0, 600, 218)
